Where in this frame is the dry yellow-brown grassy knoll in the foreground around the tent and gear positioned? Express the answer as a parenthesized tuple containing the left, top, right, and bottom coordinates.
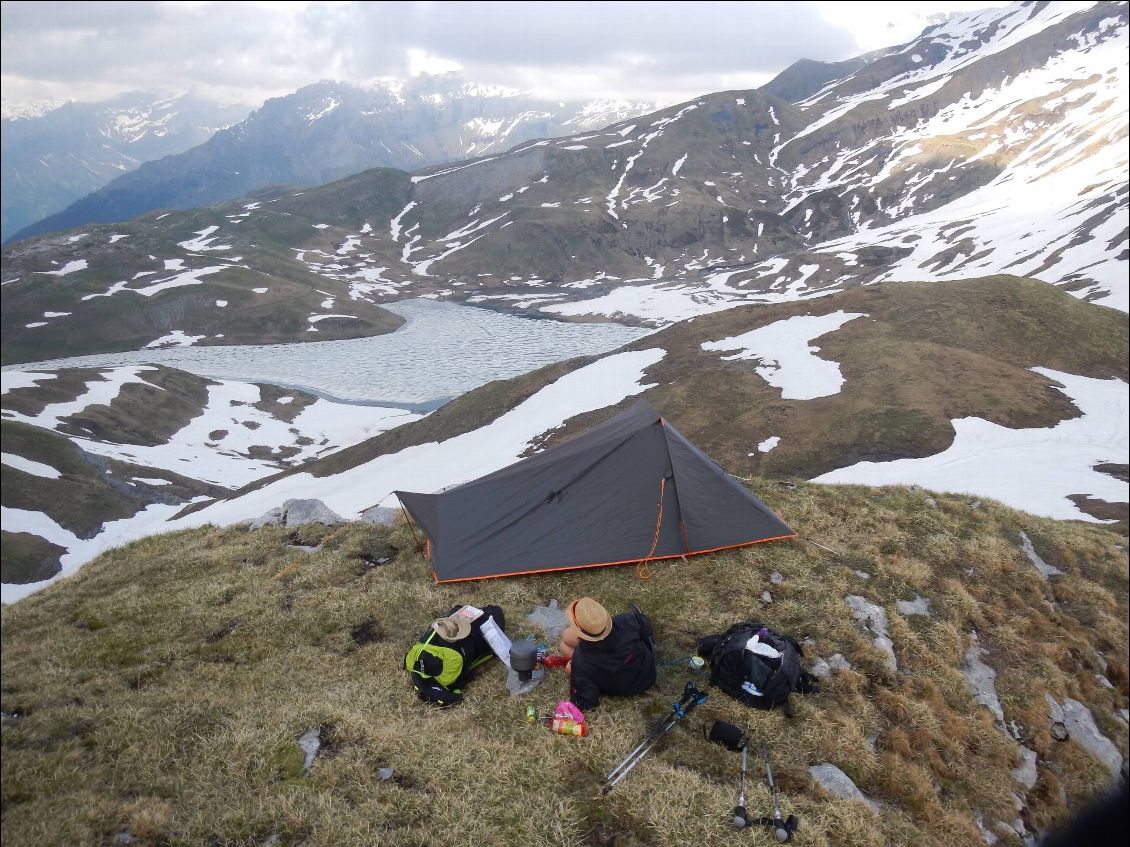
(0, 480, 1128, 847)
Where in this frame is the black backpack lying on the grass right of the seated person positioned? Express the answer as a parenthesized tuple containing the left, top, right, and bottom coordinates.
(698, 621, 816, 710)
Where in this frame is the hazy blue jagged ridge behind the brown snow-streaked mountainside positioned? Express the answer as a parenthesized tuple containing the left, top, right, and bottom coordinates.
(5, 75, 654, 242)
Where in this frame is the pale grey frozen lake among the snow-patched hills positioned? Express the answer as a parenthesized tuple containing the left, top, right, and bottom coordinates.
(5, 299, 649, 409)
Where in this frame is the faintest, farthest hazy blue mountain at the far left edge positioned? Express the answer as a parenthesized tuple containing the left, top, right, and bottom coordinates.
(0, 91, 247, 242)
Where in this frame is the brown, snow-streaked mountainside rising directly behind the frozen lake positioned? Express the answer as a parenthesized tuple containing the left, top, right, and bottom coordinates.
(2, 2, 1130, 364)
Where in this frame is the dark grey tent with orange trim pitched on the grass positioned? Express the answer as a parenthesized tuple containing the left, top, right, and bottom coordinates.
(396, 401, 796, 583)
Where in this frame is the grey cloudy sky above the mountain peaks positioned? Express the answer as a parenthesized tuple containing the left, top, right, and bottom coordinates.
(0, 0, 1003, 107)
